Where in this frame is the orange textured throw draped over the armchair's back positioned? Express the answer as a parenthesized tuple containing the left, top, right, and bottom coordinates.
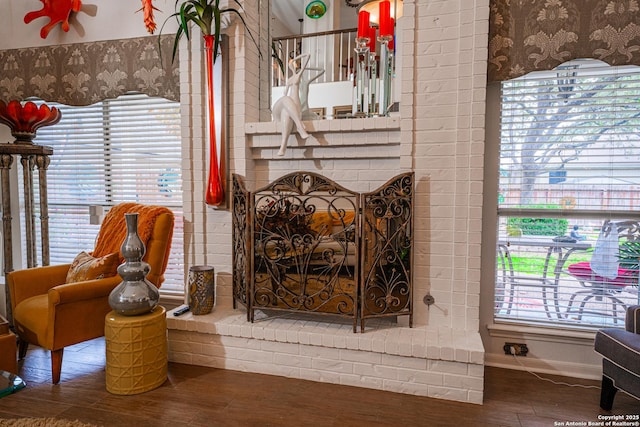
(92, 203, 173, 262)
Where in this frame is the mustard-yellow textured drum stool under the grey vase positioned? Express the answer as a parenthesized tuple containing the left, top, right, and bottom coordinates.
(104, 305, 168, 394)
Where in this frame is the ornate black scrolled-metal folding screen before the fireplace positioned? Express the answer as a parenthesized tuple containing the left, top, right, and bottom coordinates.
(233, 172, 413, 332)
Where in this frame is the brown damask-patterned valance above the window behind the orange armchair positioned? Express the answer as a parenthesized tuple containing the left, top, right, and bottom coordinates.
(0, 35, 180, 106)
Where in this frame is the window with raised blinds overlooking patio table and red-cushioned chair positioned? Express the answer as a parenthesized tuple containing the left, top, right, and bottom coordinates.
(494, 59, 640, 329)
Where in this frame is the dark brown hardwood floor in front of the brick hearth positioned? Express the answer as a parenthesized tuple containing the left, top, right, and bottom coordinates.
(0, 339, 640, 427)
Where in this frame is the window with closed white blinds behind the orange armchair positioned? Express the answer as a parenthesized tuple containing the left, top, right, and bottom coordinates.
(18, 94, 184, 295)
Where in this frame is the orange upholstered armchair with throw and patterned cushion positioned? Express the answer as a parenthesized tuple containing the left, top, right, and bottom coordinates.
(7, 203, 173, 384)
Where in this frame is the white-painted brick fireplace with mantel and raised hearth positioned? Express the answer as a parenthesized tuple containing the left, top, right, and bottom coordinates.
(168, 0, 489, 404)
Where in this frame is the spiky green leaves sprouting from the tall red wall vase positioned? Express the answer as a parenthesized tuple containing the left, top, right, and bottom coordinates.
(160, 0, 258, 61)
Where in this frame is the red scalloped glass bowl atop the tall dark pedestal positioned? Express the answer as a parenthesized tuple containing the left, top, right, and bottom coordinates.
(0, 100, 62, 144)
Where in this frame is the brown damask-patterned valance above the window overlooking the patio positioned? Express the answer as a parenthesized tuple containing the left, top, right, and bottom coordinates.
(488, 0, 640, 81)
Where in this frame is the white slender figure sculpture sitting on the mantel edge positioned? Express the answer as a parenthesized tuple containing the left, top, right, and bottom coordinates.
(272, 53, 310, 156)
